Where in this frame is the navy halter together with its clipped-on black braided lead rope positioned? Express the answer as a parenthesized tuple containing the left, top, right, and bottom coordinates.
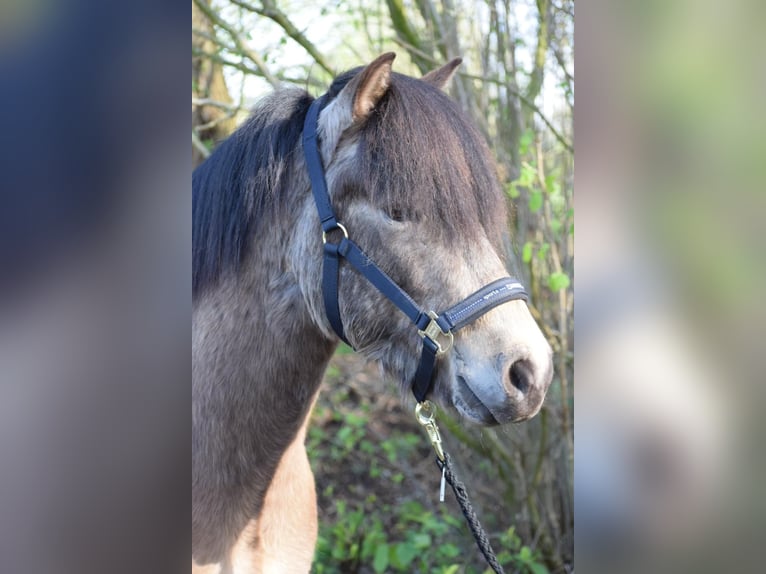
(303, 94, 527, 574)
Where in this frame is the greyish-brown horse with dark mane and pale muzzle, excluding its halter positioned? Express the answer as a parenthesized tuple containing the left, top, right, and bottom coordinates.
(192, 53, 552, 574)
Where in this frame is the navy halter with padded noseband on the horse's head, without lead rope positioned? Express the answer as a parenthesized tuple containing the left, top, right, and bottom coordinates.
(303, 95, 528, 403)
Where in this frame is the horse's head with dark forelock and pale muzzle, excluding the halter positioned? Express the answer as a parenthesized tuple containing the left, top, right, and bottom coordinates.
(296, 54, 552, 425)
